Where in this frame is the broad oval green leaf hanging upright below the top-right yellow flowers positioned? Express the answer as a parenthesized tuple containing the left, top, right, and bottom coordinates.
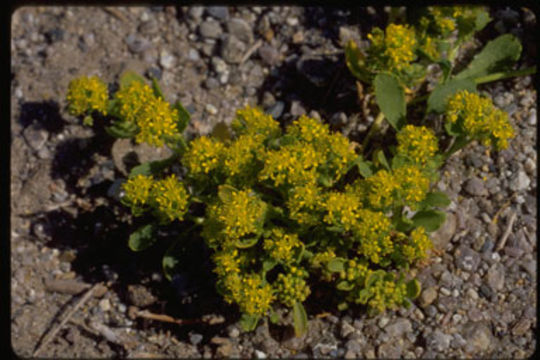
(373, 73, 407, 130)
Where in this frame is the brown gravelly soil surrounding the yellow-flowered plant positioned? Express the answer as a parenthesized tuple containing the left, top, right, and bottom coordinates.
(10, 7, 537, 359)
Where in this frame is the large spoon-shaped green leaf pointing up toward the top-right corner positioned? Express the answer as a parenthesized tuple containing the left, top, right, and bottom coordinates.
(455, 34, 521, 79)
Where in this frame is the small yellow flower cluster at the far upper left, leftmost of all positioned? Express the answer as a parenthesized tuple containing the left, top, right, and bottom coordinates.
(67, 76, 109, 116)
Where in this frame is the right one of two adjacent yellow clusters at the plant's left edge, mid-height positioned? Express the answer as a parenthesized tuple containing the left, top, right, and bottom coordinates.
(152, 174, 188, 221)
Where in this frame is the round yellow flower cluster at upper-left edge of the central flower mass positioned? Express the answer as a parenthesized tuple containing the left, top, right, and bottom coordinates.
(182, 136, 225, 175)
